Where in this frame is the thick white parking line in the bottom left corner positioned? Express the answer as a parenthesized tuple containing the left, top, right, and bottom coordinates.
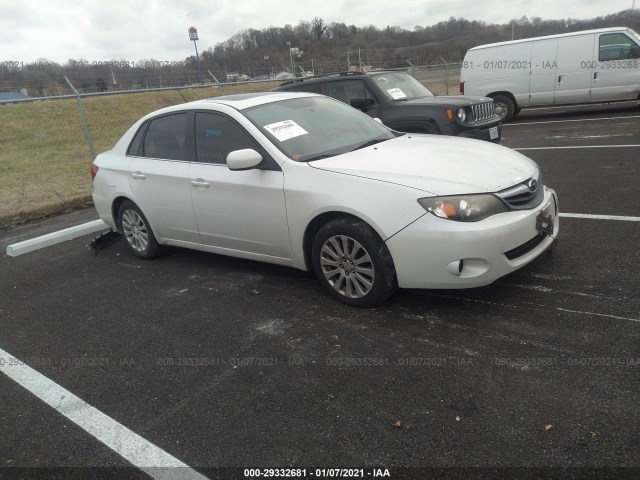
(0, 349, 207, 480)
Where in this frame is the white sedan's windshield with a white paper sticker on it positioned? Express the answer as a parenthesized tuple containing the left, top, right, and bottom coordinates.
(242, 96, 395, 162)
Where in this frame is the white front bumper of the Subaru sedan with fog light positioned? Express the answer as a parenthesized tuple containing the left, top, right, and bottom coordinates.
(386, 187, 560, 289)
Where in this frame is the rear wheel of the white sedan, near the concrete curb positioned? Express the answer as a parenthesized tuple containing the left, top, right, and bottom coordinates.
(118, 200, 159, 259)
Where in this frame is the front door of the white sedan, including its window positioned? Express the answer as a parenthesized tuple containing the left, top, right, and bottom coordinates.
(188, 112, 291, 259)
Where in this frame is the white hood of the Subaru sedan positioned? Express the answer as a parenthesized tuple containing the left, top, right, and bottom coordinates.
(309, 134, 538, 195)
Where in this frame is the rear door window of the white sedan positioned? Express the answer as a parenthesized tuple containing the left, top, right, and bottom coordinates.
(142, 113, 187, 160)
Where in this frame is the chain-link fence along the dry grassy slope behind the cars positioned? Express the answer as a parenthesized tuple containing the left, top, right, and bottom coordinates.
(0, 64, 460, 228)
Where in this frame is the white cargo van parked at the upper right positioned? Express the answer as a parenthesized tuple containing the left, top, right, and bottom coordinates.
(460, 27, 640, 122)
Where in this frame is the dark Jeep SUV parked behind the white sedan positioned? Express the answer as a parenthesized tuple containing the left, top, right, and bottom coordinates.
(273, 72, 502, 143)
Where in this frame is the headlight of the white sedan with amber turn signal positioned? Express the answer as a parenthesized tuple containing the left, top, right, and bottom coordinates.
(418, 194, 509, 222)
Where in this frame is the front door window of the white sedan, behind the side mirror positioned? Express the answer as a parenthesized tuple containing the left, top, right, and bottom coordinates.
(196, 112, 266, 165)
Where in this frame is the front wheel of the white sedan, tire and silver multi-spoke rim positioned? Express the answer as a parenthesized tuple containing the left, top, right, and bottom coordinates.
(311, 217, 398, 307)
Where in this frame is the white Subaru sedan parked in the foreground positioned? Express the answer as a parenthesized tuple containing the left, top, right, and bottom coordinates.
(92, 92, 559, 307)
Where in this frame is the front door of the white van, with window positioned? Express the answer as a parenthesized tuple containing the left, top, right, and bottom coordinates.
(591, 32, 640, 102)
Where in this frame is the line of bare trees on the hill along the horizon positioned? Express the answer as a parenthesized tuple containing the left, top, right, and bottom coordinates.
(0, 10, 640, 96)
